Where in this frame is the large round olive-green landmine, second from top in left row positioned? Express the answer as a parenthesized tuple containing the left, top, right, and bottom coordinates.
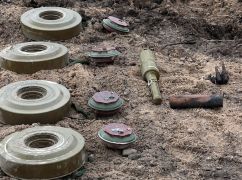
(0, 42, 68, 74)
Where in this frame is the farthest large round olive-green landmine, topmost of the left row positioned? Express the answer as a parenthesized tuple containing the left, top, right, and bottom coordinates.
(21, 7, 82, 40)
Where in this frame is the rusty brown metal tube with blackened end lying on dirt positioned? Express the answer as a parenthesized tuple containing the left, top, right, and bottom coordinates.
(169, 95, 223, 109)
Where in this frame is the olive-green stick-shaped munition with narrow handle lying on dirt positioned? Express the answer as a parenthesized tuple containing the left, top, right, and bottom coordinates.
(140, 49, 161, 104)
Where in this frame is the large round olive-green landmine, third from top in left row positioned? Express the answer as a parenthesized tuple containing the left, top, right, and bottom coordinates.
(0, 80, 70, 125)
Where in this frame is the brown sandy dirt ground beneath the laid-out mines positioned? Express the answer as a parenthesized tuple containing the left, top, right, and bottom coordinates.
(0, 0, 242, 179)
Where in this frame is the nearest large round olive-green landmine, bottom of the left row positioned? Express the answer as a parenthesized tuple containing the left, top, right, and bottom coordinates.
(0, 126, 86, 180)
